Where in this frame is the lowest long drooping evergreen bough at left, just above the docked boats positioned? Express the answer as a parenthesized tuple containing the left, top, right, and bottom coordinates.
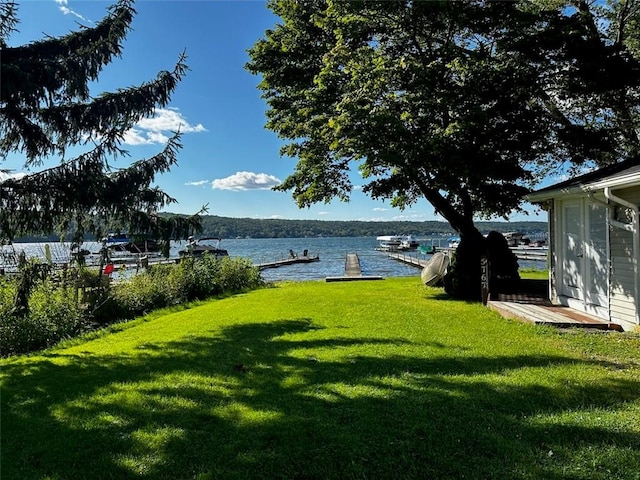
(0, 133, 181, 236)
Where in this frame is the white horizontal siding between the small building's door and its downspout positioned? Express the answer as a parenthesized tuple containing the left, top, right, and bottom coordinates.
(609, 187, 640, 325)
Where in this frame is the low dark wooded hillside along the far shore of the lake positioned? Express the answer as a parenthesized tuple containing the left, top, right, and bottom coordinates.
(11, 213, 547, 242)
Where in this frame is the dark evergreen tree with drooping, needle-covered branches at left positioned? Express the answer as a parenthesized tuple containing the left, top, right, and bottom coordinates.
(0, 0, 199, 246)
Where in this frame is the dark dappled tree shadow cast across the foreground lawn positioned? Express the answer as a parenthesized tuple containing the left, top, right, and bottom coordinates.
(2, 319, 640, 479)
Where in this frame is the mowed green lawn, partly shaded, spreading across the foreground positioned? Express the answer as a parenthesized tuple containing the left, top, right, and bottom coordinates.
(0, 278, 640, 480)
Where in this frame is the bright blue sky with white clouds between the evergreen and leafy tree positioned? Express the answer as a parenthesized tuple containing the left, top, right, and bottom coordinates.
(0, 0, 546, 221)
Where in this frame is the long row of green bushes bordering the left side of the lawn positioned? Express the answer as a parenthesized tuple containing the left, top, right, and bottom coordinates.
(0, 255, 264, 356)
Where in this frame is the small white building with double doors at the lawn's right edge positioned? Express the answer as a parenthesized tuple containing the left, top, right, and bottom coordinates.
(527, 158, 640, 330)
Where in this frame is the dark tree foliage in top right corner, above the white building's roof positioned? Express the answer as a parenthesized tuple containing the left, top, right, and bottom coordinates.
(515, 0, 640, 167)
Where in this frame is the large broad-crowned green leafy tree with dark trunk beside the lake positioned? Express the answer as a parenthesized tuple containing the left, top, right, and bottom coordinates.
(247, 0, 637, 298)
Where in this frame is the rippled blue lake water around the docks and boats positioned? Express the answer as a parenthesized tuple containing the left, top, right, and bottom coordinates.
(0, 237, 545, 281)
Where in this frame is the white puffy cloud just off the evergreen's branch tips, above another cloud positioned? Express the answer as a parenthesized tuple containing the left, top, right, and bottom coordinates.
(124, 108, 207, 145)
